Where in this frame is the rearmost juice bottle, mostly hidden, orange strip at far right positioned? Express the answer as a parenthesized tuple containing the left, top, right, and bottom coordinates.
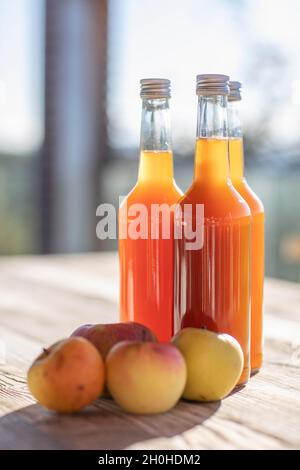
(228, 82, 264, 373)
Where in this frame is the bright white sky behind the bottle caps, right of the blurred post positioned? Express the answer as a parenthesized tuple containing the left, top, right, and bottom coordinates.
(108, 0, 300, 149)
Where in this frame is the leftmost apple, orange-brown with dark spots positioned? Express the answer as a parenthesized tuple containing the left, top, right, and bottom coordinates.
(27, 337, 105, 413)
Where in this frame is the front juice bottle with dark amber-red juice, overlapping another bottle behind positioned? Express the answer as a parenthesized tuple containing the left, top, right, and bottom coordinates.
(174, 74, 251, 384)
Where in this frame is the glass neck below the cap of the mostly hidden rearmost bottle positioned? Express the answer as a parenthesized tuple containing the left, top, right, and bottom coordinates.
(228, 101, 244, 185)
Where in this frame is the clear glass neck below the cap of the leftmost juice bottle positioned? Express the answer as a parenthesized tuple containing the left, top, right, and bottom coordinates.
(138, 98, 173, 183)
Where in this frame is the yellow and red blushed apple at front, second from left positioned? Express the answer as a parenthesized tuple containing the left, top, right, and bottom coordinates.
(106, 341, 186, 415)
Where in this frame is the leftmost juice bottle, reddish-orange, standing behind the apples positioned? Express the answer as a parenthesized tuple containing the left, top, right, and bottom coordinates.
(119, 79, 182, 341)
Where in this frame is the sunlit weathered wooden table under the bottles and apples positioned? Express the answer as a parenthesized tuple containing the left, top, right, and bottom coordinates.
(0, 253, 300, 449)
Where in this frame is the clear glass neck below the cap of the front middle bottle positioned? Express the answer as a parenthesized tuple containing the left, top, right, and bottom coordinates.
(195, 95, 229, 185)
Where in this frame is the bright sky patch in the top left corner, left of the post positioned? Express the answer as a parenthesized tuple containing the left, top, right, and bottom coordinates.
(0, 0, 44, 153)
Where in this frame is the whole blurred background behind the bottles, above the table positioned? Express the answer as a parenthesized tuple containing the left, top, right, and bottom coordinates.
(0, 0, 300, 282)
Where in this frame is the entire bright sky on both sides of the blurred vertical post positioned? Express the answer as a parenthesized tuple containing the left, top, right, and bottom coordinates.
(0, 0, 300, 157)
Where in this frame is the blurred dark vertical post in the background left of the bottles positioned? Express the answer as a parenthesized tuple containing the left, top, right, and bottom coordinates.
(41, 0, 107, 252)
